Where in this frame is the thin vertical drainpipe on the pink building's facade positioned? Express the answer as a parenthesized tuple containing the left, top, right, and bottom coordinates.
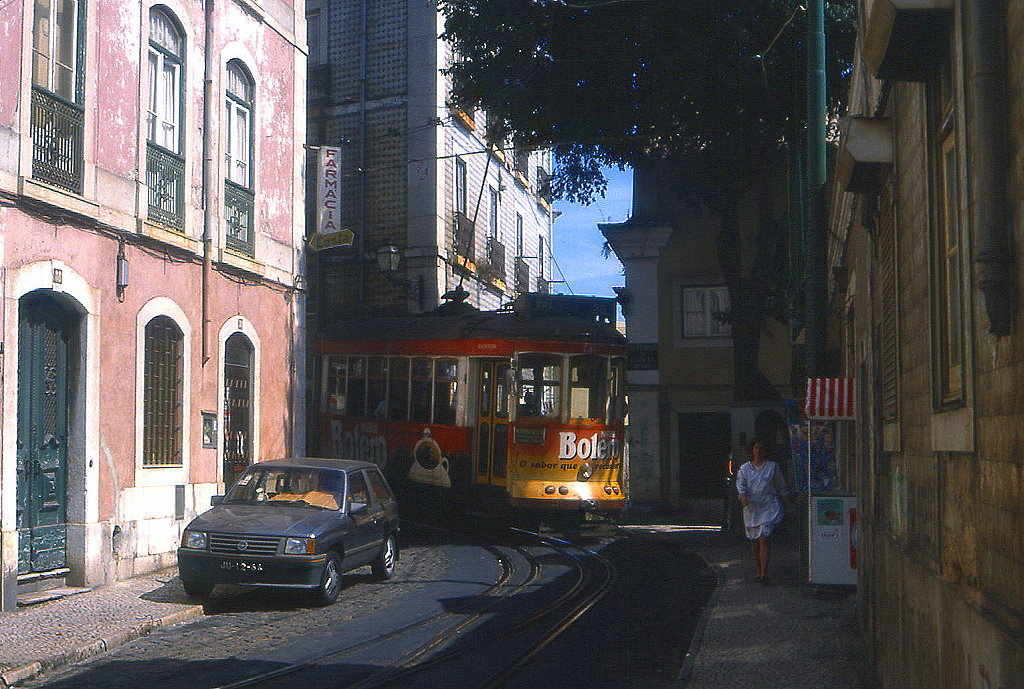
(201, 0, 217, 367)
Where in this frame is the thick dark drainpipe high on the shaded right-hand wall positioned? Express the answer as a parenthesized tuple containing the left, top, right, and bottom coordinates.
(967, 0, 1015, 337)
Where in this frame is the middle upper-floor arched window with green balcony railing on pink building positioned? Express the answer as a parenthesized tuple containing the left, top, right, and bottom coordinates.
(145, 7, 185, 230)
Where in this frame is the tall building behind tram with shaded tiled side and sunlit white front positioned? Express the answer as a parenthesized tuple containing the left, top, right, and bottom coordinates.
(306, 0, 553, 318)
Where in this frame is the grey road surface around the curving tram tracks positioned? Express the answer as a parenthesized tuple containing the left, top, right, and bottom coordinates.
(26, 522, 714, 689)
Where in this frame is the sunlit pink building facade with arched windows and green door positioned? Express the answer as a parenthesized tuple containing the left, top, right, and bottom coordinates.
(0, 0, 306, 609)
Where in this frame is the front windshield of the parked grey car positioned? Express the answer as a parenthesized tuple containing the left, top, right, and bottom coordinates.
(224, 467, 345, 510)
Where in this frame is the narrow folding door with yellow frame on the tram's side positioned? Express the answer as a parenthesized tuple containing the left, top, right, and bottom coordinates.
(475, 359, 510, 485)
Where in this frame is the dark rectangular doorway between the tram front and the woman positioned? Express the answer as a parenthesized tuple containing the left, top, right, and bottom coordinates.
(679, 412, 731, 498)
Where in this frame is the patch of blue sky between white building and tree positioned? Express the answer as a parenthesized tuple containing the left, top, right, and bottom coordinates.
(551, 168, 633, 297)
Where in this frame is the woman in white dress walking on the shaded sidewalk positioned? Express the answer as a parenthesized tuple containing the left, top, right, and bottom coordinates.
(736, 438, 788, 584)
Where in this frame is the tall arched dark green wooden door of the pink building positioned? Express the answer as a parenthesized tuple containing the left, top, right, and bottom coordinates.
(17, 296, 70, 573)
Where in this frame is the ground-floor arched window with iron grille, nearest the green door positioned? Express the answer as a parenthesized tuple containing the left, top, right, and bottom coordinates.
(142, 315, 184, 467)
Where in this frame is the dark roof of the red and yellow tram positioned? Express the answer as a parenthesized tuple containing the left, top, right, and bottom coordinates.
(319, 295, 626, 354)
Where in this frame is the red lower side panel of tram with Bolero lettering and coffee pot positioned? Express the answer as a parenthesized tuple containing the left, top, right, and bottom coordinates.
(326, 419, 470, 488)
